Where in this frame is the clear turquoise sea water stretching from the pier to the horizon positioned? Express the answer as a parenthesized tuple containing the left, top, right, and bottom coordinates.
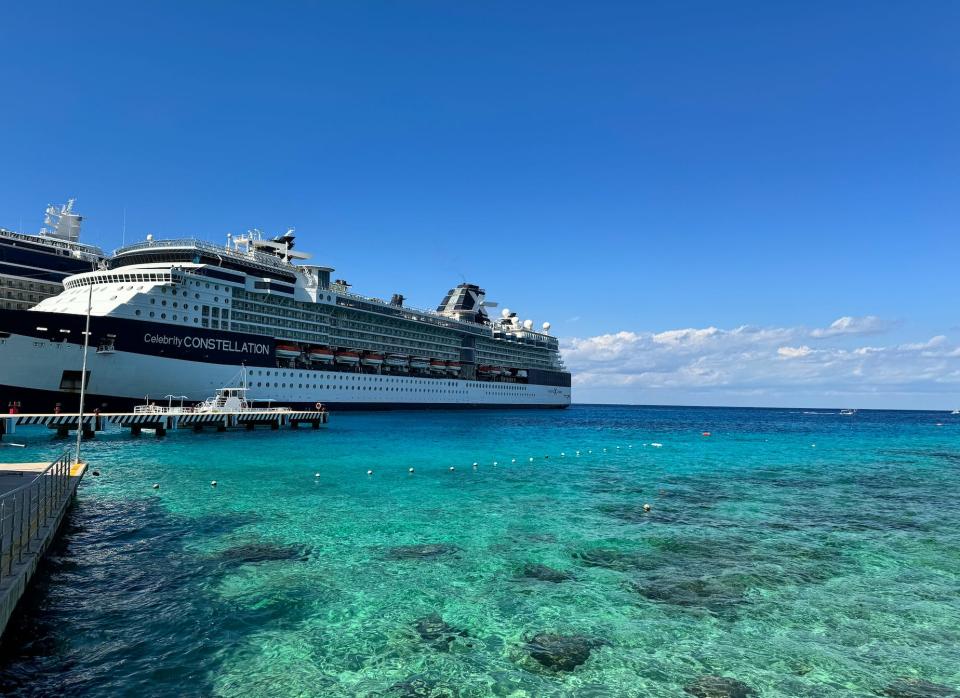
(0, 406, 960, 697)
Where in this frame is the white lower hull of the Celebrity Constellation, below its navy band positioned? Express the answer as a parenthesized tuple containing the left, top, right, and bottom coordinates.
(0, 334, 571, 412)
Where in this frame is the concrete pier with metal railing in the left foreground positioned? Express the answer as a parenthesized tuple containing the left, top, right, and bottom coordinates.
(0, 453, 87, 634)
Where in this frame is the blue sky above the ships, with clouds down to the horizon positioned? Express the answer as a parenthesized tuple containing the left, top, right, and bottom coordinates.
(0, 2, 960, 407)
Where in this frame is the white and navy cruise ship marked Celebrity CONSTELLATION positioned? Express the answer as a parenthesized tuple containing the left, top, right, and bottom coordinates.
(0, 230, 571, 412)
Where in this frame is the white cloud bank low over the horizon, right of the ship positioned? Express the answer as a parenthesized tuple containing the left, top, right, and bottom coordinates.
(561, 315, 960, 409)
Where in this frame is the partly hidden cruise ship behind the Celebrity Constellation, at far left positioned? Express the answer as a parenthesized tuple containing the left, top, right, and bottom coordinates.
(0, 199, 105, 310)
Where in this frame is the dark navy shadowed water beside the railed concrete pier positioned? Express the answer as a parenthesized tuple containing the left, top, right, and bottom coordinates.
(0, 498, 289, 696)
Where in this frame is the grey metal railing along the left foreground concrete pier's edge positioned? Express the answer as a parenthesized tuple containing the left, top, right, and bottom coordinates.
(0, 451, 73, 581)
